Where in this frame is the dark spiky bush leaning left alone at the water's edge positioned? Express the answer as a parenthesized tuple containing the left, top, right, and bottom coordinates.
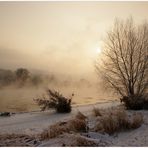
(34, 89, 72, 113)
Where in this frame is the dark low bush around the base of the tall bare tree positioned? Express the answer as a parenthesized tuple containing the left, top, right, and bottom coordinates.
(120, 95, 148, 110)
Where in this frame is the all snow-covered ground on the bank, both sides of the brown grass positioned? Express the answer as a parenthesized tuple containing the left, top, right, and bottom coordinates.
(0, 102, 148, 146)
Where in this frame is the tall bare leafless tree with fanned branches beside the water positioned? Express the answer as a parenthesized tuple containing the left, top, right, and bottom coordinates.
(96, 18, 148, 110)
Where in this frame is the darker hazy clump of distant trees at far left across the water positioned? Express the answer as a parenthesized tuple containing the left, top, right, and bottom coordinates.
(0, 68, 55, 87)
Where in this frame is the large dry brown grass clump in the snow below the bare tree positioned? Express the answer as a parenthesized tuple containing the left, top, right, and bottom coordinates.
(95, 110, 143, 135)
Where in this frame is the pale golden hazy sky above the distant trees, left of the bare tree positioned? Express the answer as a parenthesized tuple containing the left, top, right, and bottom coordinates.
(0, 1, 148, 78)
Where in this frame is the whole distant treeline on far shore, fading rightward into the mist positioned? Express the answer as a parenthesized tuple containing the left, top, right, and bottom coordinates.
(0, 68, 91, 88)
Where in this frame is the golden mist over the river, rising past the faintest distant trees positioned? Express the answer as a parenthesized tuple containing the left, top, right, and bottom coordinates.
(0, 70, 112, 112)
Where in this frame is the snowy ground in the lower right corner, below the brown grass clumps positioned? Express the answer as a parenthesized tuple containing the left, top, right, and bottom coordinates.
(37, 111, 148, 147)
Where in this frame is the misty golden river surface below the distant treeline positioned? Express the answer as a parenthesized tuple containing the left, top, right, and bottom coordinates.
(0, 79, 115, 111)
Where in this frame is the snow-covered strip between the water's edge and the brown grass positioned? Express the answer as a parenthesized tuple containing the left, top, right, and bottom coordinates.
(0, 102, 118, 134)
